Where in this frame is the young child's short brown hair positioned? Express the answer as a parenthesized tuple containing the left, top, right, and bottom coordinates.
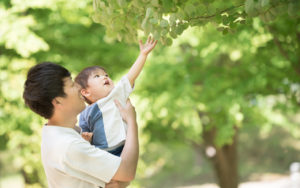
(75, 65, 106, 104)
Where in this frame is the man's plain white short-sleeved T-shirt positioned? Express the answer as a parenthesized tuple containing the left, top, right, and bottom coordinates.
(41, 125, 121, 188)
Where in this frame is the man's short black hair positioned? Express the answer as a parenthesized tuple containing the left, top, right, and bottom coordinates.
(23, 62, 71, 119)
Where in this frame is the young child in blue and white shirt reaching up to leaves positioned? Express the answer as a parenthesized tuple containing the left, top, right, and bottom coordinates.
(75, 36, 157, 156)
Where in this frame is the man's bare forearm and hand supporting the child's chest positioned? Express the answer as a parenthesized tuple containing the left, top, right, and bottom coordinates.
(112, 100, 139, 182)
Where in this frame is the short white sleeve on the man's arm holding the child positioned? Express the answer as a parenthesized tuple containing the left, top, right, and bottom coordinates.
(63, 139, 121, 187)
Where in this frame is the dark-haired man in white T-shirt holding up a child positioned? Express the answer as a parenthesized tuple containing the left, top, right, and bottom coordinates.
(23, 62, 139, 188)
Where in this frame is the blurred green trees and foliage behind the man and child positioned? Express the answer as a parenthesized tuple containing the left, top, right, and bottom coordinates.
(0, 0, 300, 188)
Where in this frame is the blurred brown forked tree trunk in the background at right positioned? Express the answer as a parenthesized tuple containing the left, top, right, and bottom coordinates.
(203, 125, 238, 188)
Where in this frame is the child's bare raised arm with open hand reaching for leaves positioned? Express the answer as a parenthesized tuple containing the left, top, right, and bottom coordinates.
(127, 36, 157, 87)
